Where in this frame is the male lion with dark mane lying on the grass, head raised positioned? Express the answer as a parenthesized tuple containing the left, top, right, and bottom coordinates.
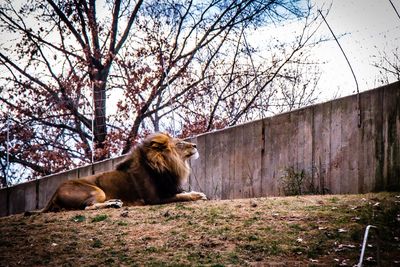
(33, 133, 207, 212)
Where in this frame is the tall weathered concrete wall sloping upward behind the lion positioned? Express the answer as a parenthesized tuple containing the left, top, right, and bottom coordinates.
(0, 82, 400, 216)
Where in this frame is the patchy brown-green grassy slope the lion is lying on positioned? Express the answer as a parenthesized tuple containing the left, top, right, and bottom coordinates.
(0, 193, 400, 266)
